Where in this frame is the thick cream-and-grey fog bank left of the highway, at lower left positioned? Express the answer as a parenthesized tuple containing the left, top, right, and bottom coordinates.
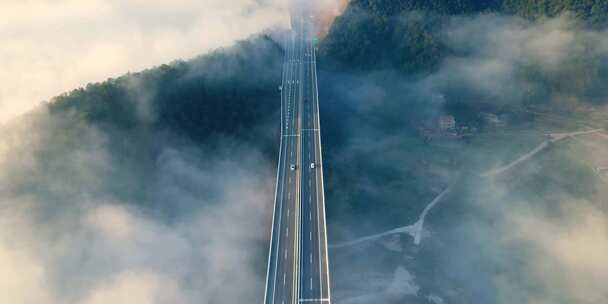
(0, 111, 274, 304)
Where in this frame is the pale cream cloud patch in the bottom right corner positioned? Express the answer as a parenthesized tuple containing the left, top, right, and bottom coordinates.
(507, 201, 608, 303)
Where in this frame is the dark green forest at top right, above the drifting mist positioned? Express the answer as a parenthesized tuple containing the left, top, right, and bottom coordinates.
(321, 0, 608, 73)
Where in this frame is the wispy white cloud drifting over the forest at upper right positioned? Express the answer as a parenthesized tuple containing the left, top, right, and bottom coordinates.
(422, 14, 608, 105)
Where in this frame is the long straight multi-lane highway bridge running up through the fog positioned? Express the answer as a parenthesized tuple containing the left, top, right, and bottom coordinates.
(264, 16, 331, 304)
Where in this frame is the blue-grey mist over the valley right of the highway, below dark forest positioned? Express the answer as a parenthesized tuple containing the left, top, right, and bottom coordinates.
(320, 13, 608, 304)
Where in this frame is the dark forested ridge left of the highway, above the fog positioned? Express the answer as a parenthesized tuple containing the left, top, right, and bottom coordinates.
(49, 36, 282, 150)
